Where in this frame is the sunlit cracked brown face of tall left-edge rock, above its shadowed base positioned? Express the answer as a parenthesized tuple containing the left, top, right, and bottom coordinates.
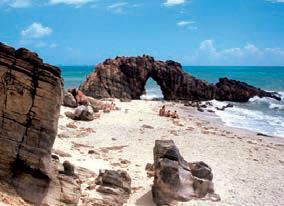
(0, 44, 62, 177)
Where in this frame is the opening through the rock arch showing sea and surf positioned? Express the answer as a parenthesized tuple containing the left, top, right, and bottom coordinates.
(140, 77, 164, 100)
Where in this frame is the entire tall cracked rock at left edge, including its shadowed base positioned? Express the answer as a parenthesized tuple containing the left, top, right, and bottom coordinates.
(0, 43, 78, 205)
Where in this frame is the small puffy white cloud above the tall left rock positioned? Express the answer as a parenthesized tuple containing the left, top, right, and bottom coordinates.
(21, 22, 52, 39)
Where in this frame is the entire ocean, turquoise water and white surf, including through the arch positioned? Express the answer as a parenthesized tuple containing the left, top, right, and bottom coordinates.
(61, 66, 284, 137)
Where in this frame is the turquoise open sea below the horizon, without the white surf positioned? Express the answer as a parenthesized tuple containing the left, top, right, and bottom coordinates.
(60, 66, 284, 91)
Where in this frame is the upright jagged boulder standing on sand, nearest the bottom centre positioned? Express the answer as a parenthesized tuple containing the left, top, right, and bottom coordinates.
(152, 140, 220, 206)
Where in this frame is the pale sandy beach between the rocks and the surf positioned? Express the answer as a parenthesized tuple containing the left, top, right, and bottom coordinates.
(51, 100, 284, 206)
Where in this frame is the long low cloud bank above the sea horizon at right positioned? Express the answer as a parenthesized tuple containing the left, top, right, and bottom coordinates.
(189, 39, 284, 65)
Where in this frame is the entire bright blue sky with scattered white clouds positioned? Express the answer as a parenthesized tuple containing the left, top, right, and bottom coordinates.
(0, 0, 284, 66)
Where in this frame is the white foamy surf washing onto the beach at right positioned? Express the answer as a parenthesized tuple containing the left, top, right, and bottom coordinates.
(212, 92, 284, 137)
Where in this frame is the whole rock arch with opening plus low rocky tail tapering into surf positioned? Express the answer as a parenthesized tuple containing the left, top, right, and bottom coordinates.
(80, 55, 280, 102)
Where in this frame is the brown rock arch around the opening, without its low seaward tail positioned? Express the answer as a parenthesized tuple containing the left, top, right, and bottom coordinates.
(80, 55, 217, 100)
